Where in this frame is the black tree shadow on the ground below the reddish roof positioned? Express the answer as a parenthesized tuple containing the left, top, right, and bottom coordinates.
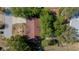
(27, 36, 44, 51)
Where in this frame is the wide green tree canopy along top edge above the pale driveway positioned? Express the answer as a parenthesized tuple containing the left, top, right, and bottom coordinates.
(11, 7, 42, 18)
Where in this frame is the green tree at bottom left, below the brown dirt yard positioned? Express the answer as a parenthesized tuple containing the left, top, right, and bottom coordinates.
(6, 36, 30, 51)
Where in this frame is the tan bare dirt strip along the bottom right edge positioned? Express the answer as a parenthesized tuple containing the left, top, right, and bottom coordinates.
(44, 43, 79, 51)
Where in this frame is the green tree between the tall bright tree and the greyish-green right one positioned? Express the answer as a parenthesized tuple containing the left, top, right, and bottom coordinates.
(54, 16, 66, 36)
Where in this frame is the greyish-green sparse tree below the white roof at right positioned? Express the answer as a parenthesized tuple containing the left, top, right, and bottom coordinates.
(60, 26, 78, 43)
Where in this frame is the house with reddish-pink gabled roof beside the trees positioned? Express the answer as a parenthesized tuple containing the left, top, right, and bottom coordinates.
(26, 18, 40, 38)
